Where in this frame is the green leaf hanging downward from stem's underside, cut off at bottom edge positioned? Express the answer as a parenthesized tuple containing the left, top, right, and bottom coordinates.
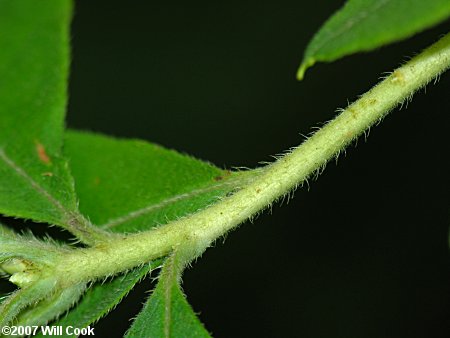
(125, 252, 210, 338)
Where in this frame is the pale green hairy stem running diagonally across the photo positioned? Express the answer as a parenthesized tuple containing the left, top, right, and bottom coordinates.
(55, 34, 450, 283)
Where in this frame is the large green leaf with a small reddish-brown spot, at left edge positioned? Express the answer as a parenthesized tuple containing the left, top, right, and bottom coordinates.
(0, 0, 85, 231)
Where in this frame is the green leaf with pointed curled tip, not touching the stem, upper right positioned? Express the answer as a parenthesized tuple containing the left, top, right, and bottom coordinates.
(297, 0, 450, 80)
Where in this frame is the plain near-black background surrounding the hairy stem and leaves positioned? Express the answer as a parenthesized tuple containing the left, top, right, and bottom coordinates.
(25, 0, 450, 338)
